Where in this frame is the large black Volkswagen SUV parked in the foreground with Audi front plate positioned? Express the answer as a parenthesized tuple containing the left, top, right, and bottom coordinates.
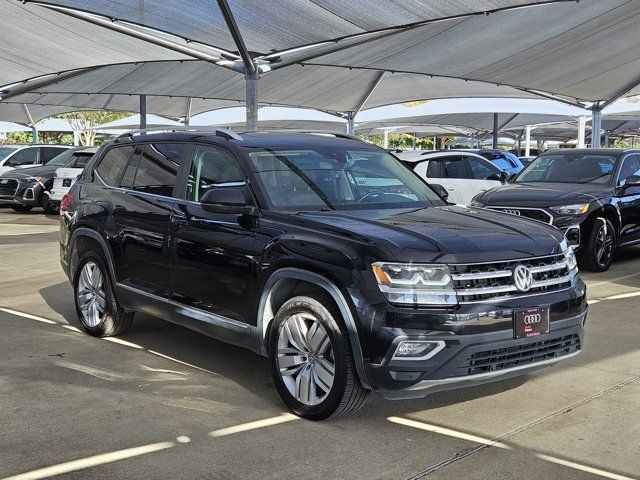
(60, 128, 587, 420)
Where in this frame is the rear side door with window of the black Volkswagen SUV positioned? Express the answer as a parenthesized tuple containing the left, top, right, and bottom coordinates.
(109, 142, 189, 298)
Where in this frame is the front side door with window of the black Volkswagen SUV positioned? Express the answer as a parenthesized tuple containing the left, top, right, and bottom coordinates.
(170, 145, 258, 326)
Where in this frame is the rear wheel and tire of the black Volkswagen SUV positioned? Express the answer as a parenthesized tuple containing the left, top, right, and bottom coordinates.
(73, 251, 134, 337)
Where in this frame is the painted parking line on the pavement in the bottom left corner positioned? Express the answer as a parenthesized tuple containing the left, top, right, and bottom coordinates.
(2, 442, 177, 480)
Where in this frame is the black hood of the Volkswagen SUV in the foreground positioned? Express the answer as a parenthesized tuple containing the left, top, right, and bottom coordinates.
(297, 205, 564, 263)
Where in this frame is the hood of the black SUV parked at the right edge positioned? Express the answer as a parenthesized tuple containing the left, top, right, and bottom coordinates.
(475, 183, 611, 207)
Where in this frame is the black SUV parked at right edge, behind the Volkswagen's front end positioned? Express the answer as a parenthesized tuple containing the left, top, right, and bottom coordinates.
(472, 148, 640, 272)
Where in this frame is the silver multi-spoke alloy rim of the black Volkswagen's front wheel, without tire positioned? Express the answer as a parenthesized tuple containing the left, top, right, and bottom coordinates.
(277, 312, 335, 405)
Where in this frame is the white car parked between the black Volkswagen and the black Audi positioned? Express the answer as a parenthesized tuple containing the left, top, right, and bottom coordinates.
(395, 151, 508, 205)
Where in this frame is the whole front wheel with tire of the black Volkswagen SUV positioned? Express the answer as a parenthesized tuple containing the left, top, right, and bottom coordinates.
(269, 296, 369, 420)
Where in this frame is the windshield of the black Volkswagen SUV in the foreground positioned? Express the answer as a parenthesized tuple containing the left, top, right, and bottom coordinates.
(242, 147, 444, 211)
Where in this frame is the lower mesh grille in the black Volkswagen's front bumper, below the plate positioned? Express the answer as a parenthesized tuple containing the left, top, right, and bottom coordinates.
(453, 333, 580, 376)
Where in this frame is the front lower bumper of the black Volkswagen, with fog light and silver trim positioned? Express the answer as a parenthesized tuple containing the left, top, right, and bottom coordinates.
(366, 307, 587, 399)
